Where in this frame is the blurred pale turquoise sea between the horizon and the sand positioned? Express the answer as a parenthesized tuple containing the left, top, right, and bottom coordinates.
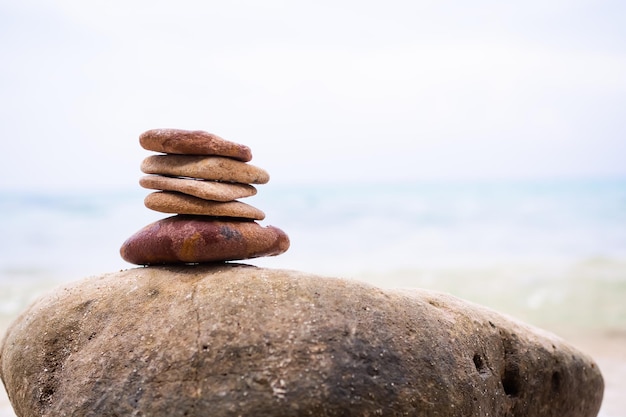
(0, 179, 626, 329)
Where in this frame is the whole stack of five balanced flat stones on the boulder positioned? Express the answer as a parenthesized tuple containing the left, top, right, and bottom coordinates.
(120, 129, 289, 265)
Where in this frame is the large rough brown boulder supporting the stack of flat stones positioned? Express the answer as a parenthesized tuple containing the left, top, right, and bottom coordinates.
(0, 264, 603, 417)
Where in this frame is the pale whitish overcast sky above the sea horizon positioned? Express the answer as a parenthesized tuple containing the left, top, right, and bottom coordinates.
(0, 0, 626, 189)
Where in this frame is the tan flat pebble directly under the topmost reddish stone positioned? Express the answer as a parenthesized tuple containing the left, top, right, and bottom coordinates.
(141, 155, 270, 184)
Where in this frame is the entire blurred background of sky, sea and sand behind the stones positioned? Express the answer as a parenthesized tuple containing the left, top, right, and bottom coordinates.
(0, 0, 626, 417)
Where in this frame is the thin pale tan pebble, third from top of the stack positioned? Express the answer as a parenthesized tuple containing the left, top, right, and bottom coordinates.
(139, 175, 256, 201)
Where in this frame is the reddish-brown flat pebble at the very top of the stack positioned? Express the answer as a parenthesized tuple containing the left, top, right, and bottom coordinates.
(139, 129, 252, 162)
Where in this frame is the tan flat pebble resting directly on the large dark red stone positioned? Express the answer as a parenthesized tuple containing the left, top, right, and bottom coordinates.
(144, 191, 265, 220)
